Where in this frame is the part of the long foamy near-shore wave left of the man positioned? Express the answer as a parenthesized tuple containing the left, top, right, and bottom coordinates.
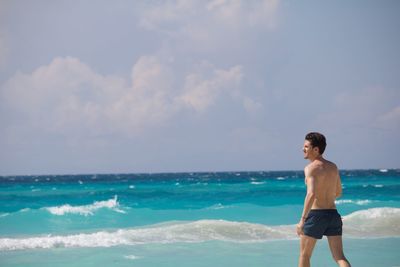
(0, 220, 296, 251)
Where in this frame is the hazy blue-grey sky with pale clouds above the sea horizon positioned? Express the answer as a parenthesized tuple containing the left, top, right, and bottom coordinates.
(0, 0, 400, 175)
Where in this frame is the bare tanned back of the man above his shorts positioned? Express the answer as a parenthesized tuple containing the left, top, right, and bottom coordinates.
(305, 158, 341, 209)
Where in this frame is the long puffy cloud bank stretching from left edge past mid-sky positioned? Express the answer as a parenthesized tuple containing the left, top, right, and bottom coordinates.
(0, 56, 253, 140)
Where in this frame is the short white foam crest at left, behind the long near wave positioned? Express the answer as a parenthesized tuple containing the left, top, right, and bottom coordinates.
(44, 196, 125, 216)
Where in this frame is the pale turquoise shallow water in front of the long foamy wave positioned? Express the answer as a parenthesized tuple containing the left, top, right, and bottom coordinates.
(0, 238, 400, 267)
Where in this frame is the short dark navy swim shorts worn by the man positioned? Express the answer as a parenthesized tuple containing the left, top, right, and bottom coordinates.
(303, 209, 343, 239)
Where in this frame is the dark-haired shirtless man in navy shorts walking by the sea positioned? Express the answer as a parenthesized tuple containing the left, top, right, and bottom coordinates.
(296, 133, 350, 267)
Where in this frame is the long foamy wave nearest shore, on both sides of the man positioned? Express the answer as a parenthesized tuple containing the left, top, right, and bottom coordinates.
(0, 208, 400, 251)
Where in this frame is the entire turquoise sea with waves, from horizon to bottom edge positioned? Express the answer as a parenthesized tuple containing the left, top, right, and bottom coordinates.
(0, 169, 400, 267)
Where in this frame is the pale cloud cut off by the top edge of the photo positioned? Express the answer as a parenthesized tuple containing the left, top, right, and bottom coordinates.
(140, 0, 279, 32)
